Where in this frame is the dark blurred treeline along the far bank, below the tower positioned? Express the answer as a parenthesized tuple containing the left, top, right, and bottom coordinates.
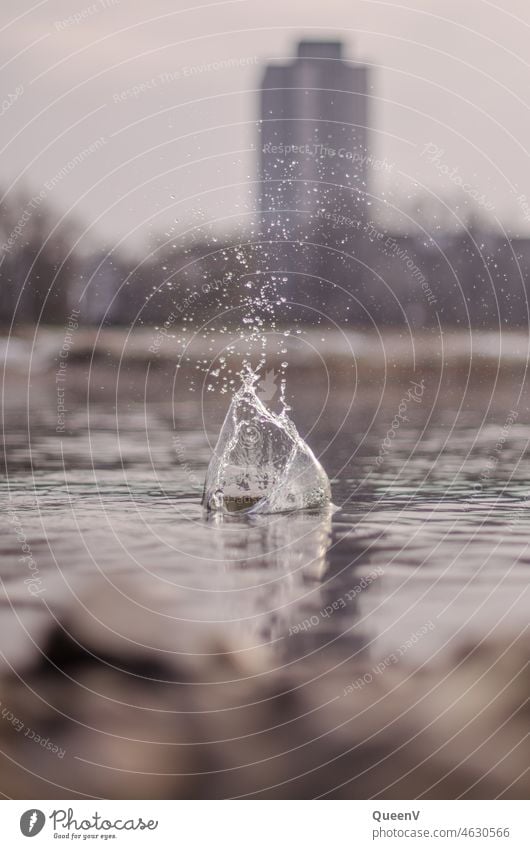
(0, 187, 530, 332)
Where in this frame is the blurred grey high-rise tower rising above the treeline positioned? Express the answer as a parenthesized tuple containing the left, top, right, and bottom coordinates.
(259, 41, 369, 224)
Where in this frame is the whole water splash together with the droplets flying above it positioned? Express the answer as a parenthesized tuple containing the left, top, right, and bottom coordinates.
(159, 205, 330, 513)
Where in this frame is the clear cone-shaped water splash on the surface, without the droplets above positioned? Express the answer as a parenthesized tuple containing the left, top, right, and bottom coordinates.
(203, 370, 331, 514)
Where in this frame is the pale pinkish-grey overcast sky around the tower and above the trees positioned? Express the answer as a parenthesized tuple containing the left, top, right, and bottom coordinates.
(0, 0, 530, 249)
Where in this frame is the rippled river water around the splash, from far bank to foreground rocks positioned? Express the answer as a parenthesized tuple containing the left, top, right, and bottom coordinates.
(0, 324, 530, 680)
